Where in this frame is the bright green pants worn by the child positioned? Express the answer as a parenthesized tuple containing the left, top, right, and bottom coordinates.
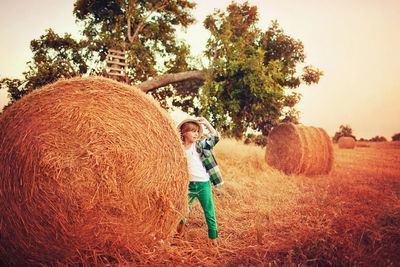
(181, 182, 218, 239)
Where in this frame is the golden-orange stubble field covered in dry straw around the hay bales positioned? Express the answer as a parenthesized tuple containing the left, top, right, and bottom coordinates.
(141, 139, 400, 266)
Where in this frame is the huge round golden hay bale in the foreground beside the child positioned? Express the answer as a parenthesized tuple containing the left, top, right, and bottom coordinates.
(0, 78, 189, 266)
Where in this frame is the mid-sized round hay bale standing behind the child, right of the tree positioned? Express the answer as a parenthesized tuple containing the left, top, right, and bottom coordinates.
(265, 123, 334, 175)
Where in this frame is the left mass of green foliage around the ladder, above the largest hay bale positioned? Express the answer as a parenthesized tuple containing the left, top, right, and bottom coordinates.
(6, 0, 198, 105)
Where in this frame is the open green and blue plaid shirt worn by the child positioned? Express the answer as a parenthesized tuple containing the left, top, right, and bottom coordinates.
(196, 134, 224, 186)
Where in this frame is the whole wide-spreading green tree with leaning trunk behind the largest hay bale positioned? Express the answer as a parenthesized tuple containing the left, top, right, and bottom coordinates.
(2, 0, 322, 137)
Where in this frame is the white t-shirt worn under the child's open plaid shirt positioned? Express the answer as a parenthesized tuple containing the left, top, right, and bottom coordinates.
(185, 142, 210, 182)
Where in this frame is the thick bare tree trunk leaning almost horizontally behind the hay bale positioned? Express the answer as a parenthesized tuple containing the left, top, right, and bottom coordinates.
(135, 70, 205, 92)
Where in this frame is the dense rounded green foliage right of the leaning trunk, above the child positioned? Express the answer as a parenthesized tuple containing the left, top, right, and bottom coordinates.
(200, 3, 322, 137)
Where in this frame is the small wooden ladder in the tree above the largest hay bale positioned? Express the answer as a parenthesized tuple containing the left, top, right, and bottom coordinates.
(106, 48, 128, 83)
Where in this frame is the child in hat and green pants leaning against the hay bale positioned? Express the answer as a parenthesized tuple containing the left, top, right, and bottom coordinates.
(177, 117, 224, 245)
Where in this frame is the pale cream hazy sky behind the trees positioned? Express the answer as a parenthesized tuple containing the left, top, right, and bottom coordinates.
(0, 0, 400, 140)
